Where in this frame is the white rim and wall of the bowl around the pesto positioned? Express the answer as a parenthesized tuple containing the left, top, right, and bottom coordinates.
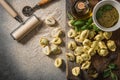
(92, 0, 120, 32)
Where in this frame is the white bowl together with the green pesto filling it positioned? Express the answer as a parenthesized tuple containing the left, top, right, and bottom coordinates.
(92, 0, 120, 32)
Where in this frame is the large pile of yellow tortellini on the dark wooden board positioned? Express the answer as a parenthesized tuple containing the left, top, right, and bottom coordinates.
(66, 28, 116, 76)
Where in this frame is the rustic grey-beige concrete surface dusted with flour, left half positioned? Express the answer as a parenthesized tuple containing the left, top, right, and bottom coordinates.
(0, 0, 66, 80)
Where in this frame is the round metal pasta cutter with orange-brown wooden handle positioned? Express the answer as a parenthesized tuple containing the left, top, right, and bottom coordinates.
(22, 0, 53, 17)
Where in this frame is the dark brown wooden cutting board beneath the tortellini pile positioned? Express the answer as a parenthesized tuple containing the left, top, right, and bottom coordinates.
(66, 0, 120, 80)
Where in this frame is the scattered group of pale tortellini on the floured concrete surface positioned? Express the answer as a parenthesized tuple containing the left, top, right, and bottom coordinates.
(40, 16, 63, 67)
